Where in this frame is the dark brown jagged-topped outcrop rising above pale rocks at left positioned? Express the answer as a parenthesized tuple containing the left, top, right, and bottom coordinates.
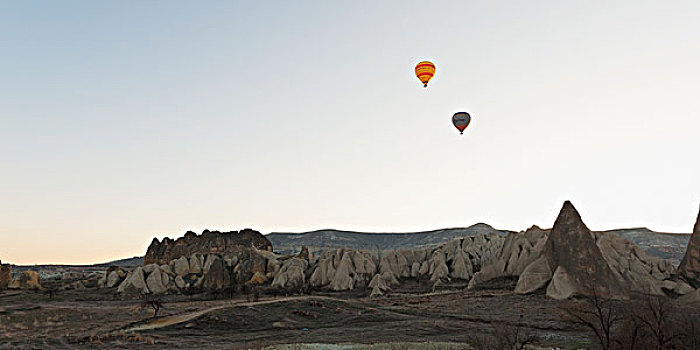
(143, 229, 272, 264)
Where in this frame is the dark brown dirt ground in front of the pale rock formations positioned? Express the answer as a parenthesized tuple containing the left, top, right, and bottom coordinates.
(0, 283, 592, 349)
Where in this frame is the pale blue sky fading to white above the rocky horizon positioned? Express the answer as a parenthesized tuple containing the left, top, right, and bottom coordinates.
(0, 1, 700, 264)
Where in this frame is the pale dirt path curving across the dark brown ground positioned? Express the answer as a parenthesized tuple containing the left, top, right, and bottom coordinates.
(123, 295, 344, 332)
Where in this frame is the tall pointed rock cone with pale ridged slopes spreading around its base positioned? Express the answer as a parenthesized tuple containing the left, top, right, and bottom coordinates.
(469, 202, 676, 299)
